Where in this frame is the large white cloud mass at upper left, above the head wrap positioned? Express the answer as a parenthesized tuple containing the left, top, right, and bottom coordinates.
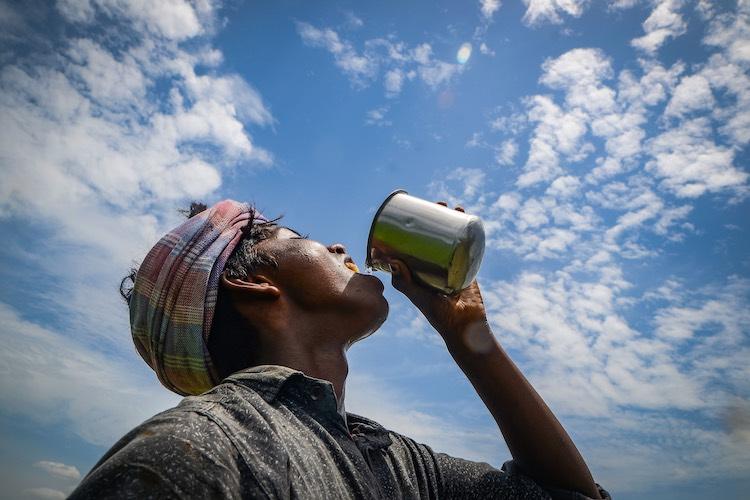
(0, 20, 272, 254)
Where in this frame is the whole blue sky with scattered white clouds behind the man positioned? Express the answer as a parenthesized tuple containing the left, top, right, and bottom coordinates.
(0, 0, 750, 499)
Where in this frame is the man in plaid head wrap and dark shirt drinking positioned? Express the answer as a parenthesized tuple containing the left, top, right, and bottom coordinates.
(71, 200, 608, 499)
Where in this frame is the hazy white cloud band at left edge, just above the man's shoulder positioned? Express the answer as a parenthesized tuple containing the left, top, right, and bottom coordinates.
(0, 304, 180, 446)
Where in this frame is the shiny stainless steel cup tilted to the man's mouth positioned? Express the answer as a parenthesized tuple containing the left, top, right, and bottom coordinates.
(366, 189, 484, 294)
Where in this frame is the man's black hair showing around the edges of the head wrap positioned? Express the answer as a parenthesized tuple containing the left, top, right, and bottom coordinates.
(120, 201, 281, 379)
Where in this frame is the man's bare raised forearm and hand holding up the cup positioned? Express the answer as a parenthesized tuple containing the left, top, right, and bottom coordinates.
(391, 261, 600, 498)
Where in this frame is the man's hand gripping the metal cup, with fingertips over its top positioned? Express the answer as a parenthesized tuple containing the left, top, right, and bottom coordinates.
(388, 202, 487, 342)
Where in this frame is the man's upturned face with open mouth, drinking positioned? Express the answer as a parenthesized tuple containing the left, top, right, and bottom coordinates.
(257, 227, 388, 342)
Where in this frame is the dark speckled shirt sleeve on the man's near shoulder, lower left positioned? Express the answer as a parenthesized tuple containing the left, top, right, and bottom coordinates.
(69, 412, 263, 500)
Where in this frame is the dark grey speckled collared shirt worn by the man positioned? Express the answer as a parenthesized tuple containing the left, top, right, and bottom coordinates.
(70, 366, 609, 500)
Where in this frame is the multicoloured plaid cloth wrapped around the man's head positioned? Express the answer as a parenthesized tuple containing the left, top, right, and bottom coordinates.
(130, 200, 267, 396)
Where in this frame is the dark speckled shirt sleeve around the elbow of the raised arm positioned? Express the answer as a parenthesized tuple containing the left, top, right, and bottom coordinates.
(435, 453, 611, 500)
